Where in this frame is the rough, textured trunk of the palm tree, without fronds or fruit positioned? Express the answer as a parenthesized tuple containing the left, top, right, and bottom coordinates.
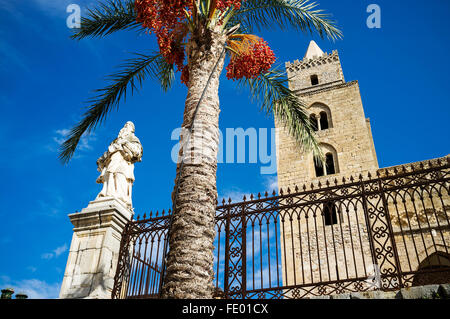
(162, 30, 225, 299)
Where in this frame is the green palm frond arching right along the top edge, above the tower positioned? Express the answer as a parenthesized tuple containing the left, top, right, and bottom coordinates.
(228, 0, 342, 40)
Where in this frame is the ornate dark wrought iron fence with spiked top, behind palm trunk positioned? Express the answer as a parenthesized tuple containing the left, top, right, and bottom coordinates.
(113, 157, 450, 299)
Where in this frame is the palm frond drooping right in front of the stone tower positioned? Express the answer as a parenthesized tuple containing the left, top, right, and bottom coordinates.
(238, 69, 323, 160)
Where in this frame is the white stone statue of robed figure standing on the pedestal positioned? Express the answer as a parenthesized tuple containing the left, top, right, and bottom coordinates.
(96, 122, 143, 210)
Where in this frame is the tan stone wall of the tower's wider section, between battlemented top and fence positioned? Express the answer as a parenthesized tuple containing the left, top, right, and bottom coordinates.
(275, 82, 378, 189)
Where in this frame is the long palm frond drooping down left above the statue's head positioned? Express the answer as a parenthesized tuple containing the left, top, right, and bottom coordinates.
(59, 54, 174, 163)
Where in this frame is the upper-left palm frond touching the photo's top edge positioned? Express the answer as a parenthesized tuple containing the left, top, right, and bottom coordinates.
(71, 0, 143, 40)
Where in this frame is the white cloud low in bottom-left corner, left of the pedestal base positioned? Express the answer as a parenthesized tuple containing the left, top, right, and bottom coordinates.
(0, 276, 61, 299)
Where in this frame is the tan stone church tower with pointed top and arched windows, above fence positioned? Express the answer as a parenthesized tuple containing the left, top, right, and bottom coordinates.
(275, 41, 378, 189)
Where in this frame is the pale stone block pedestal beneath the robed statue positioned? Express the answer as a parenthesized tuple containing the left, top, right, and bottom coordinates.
(59, 197, 133, 299)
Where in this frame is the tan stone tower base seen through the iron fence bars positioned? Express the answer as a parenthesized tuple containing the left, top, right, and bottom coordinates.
(280, 203, 375, 286)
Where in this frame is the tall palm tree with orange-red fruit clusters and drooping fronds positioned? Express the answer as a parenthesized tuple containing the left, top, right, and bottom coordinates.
(60, 0, 341, 298)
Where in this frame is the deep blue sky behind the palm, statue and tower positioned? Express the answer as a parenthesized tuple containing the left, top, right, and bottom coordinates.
(0, 0, 450, 298)
